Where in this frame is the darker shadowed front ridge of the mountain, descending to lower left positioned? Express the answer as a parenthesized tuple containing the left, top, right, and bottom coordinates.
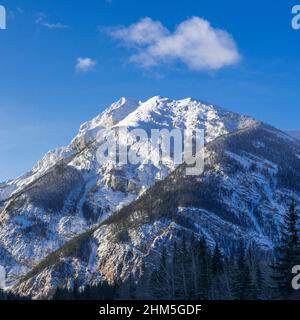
(14, 124, 300, 297)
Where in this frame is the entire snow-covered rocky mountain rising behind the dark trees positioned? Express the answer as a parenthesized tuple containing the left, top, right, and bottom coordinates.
(0, 96, 300, 296)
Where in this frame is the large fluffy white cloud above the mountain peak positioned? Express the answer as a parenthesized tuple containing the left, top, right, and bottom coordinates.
(107, 17, 240, 71)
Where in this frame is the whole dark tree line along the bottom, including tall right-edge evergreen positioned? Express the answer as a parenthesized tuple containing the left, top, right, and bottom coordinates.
(0, 201, 300, 300)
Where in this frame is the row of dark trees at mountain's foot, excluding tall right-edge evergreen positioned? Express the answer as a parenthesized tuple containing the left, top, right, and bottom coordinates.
(6, 236, 269, 300)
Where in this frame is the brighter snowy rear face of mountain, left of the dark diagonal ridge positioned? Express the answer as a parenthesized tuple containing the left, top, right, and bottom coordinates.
(0, 97, 257, 283)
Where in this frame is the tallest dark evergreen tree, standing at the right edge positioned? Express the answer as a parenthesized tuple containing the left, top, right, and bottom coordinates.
(271, 201, 300, 299)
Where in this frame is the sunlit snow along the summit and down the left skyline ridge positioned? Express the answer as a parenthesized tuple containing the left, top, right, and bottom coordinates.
(0, 96, 255, 201)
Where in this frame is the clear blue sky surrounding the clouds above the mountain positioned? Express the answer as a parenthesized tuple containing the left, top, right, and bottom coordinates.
(0, 0, 300, 181)
